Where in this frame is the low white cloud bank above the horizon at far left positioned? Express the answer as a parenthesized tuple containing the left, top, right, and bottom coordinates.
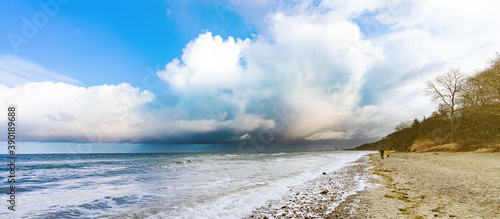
(0, 82, 153, 142)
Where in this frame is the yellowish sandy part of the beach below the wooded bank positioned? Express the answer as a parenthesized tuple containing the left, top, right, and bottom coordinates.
(356, 153, 500, 218)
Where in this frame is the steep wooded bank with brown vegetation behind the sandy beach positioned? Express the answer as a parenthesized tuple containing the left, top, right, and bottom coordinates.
(355, 53, 500, 152)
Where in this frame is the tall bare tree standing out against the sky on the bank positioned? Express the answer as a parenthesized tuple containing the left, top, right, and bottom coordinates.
(425, 68, 467, 130)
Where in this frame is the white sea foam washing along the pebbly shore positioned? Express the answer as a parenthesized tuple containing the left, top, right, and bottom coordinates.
(156, 152, 366, 218)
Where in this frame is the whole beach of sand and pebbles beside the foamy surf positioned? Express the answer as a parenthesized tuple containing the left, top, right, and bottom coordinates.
(246, 152, 500, 218)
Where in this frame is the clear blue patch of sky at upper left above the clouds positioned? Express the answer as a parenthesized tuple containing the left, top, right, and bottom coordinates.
(0, 1, 252, 86)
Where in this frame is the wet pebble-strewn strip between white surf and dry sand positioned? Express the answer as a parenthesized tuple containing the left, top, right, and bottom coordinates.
(243, 155, 373, 218)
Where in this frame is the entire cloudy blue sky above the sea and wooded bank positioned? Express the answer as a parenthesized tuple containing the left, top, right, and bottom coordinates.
(0, 0, 500, 150)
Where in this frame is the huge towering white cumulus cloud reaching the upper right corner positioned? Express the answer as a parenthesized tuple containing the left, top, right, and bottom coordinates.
(158, 0, 500, 140)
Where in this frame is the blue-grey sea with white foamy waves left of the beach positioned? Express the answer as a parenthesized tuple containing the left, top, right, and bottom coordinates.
(0, 151, 367, 218)
